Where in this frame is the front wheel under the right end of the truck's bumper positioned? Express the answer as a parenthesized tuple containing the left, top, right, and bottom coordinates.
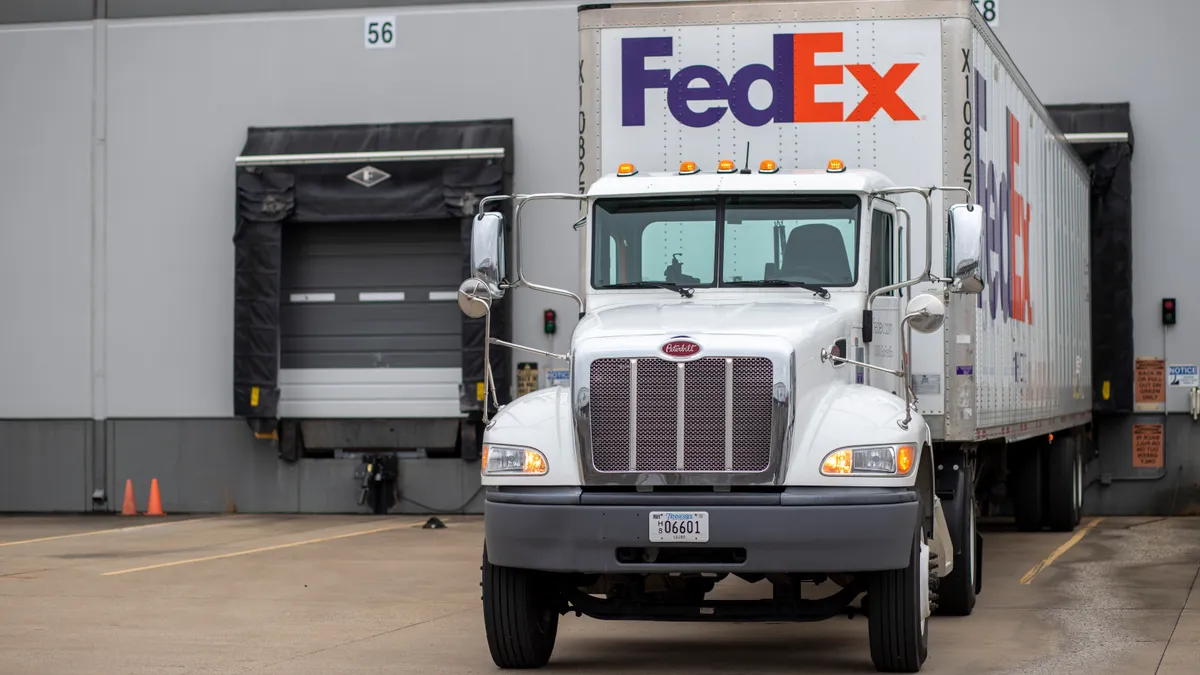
(866, 526, 935, 673)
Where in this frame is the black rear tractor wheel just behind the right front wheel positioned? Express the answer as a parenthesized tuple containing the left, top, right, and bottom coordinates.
(936, 466, 979, 616)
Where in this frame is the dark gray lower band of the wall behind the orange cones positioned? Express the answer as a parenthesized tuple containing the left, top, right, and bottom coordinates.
(0, 419, 482, 513)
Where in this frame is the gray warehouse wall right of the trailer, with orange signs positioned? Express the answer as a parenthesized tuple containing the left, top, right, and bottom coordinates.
(994, 0, 1200, 513)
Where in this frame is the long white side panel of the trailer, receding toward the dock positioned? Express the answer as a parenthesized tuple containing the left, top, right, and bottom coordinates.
(947, 22, 1092, 438)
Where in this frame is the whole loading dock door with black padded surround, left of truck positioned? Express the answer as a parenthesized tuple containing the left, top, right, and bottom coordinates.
(233, 119, 514, 432)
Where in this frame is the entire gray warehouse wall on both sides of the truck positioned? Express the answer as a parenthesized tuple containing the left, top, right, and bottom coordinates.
(0, 0, 1200, 513)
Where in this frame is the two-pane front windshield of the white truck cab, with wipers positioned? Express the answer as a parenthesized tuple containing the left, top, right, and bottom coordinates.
(592, 195, 859, 288)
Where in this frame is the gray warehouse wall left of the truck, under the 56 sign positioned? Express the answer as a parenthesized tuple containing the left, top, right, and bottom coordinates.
(0, 1, 577, 510)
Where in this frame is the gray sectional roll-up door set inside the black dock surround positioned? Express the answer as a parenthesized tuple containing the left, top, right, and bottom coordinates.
(280, 220, 462, 418)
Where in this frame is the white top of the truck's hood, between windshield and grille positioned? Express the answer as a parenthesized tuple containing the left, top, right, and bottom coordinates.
(575, 300, 853, 345)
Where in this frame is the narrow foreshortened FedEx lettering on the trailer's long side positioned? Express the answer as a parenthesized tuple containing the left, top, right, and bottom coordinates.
(974, 70, 1033, 324)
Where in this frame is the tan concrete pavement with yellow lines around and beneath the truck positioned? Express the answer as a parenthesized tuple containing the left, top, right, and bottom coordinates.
(0, 514, 1200, 675)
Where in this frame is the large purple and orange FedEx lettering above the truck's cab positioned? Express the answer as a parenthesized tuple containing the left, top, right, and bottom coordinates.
(620, 32, 920, 127)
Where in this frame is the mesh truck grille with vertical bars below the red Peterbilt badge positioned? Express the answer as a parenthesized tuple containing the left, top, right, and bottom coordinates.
(590, 357, 774, 472)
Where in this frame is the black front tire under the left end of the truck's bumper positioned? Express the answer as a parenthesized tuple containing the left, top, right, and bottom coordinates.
(482, 546, 558, 669)
